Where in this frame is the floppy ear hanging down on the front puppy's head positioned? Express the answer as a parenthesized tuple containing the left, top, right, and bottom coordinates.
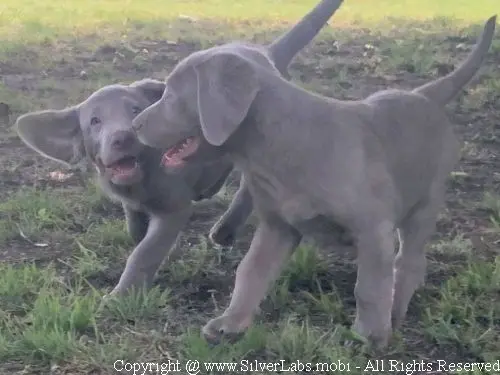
(194, 53, 259, 146)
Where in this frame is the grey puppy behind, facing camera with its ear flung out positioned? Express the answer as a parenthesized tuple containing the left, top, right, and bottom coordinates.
(16, 0, 342, 294)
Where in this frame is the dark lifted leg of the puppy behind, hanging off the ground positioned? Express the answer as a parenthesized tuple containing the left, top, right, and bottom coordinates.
(208, 176, 253, 247)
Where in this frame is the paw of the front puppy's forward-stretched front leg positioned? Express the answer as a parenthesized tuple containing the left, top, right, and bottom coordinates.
(201, 315, 252, 344)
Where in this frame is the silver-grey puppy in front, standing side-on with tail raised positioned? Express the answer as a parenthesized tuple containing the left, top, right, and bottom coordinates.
(133, 16, 496, 348)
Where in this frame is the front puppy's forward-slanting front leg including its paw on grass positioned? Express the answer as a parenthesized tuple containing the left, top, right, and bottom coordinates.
(202, 218, 301, 342)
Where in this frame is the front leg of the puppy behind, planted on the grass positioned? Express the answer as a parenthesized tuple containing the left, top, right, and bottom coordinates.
(111, 205, 192, 294)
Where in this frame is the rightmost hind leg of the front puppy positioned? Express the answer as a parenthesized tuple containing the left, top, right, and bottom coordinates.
(392, 201, 440, 328)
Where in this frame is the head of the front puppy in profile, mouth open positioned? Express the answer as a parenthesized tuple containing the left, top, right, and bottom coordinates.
(133, 46, 262, 166)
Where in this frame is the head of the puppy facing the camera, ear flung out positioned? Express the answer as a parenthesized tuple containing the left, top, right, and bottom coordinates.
(15, 79, 165, 185)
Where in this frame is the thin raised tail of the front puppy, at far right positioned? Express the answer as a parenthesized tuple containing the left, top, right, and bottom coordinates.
(413, 15, 497, 106)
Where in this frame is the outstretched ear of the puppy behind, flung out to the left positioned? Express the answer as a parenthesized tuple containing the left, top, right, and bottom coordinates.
(15, 107, 85, 166)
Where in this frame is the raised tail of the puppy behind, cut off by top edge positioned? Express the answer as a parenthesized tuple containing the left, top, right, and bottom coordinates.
(268, 0, 343, 79)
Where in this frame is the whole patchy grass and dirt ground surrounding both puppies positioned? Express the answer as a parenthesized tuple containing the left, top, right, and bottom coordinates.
(0, 0, 500, 374)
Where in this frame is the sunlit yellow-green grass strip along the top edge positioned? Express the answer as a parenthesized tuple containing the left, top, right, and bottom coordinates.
(0, 0, 498, 48)
